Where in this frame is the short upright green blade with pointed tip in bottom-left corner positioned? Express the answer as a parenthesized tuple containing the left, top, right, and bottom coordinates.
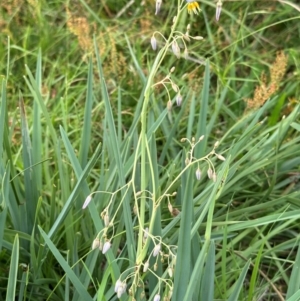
(6, 234, 19, 301)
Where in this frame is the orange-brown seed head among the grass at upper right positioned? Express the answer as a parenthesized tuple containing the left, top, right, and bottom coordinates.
(245, 51, 288, 111)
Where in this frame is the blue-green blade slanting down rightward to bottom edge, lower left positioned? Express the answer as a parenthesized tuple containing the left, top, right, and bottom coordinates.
(38, 226, 93, 301)
